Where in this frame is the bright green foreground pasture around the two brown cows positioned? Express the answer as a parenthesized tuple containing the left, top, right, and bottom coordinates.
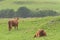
(0, 16, 60, 40)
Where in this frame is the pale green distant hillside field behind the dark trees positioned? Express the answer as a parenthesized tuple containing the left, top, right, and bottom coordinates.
(0, 0, 60, 11)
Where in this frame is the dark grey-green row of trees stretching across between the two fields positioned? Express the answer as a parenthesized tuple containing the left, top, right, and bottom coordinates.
(0, 7, 59, 18)
